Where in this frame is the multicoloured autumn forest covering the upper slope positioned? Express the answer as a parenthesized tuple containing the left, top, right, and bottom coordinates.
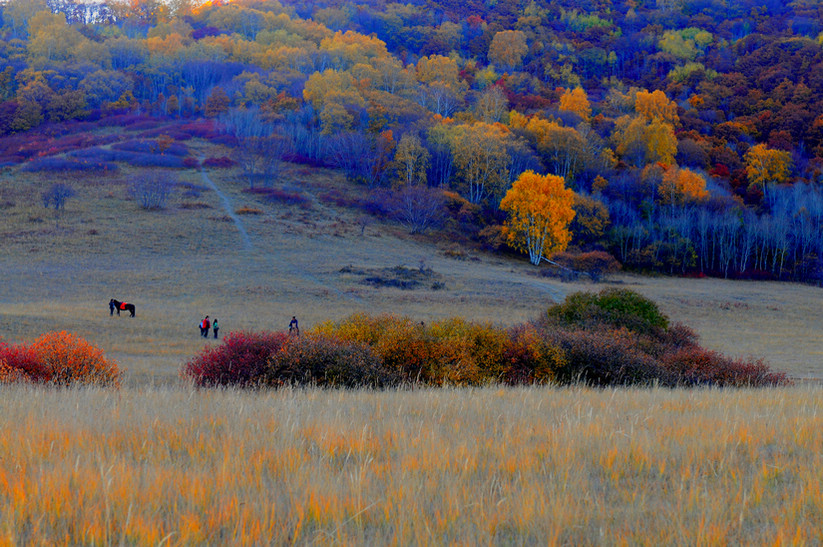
(0, 0, 823, 283)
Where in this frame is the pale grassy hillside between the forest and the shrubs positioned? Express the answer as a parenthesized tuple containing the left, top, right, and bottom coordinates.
(0, 133, 823, 383)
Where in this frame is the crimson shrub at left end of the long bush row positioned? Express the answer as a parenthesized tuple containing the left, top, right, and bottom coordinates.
(181, 332, 288, 387)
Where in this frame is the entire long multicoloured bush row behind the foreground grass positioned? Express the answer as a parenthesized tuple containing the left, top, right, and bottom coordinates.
(181, 289, 788, 387)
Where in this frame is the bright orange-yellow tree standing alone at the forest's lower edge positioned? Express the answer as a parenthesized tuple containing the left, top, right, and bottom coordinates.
(500, 171, 575, 266)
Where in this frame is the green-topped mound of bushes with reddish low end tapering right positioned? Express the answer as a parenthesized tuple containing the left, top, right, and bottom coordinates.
(541, 289, 789, 387)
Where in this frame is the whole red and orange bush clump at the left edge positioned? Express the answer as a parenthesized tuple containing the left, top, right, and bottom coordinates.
(0, 331, 122, 387)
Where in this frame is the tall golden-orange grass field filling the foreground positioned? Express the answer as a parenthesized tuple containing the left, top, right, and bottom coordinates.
(0, 386, 823, 545)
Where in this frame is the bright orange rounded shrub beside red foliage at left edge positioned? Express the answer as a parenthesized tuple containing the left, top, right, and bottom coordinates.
(31, 331, 122, 387)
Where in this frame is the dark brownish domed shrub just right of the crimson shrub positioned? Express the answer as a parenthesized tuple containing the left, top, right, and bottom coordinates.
(263, 334, 399, 388)
